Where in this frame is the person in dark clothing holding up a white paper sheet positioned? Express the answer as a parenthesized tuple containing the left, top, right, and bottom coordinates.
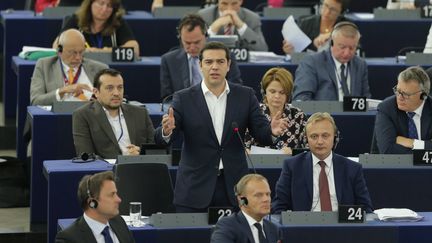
(282, 0, 349, 54)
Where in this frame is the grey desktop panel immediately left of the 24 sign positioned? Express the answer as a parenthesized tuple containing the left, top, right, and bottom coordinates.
(281, 211, 338, 225)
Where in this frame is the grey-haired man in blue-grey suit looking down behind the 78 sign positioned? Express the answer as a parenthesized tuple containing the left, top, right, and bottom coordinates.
(293, 21, 371, 101)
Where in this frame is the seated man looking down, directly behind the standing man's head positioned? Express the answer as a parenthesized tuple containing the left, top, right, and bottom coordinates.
(160, 14, 242, 99)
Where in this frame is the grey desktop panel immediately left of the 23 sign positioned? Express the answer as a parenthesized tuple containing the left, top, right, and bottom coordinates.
(149, 213, 209, 228)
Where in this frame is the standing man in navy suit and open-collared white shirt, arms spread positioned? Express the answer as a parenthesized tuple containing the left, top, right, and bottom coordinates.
(155, 42, 288, 212)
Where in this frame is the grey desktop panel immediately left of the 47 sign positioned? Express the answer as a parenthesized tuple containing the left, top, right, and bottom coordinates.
(359, 154, 413, 168)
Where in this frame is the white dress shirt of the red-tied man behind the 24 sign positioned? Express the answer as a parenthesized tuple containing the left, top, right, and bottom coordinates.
(311, 152, 338, 212)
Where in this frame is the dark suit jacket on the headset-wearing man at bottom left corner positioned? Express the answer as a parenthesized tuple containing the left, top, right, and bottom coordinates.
(55, 215, 135, 243)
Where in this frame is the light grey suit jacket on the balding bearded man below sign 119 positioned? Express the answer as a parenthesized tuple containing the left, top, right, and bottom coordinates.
(30, 56, 108, 105)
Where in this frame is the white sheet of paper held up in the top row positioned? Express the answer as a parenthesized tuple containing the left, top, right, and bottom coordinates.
(282, 15, 312, 52)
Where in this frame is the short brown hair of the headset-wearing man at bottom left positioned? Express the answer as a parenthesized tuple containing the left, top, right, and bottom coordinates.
(77, 171, 115, 210)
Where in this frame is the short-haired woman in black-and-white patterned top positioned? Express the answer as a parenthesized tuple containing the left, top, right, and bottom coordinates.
(245, 67, 307, 154)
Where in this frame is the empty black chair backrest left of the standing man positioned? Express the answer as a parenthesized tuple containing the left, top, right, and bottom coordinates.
(114, 163, 174, 216)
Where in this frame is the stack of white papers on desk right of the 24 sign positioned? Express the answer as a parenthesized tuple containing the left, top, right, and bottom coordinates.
(374, 208, 423, 222)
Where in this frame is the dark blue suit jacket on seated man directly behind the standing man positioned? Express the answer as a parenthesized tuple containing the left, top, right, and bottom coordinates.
(160, 48, 243, 99)
